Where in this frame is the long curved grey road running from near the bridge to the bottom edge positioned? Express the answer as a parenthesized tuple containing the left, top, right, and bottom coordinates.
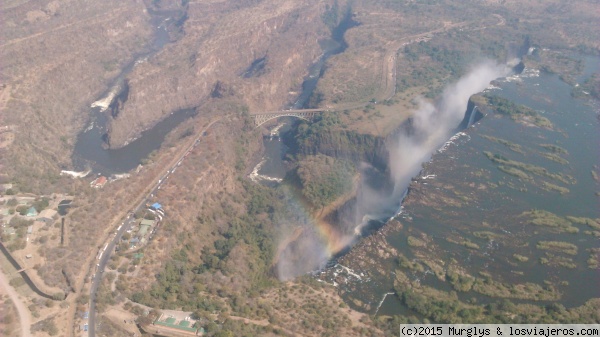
(88, 118, 220, 337)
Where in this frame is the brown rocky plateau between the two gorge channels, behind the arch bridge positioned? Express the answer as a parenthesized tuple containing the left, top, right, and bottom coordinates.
(110, 0, 330, 148)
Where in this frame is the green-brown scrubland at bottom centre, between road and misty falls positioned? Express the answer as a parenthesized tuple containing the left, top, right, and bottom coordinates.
(128, 175, 364, 336)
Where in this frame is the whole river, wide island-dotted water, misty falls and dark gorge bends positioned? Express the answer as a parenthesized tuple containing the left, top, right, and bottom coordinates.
(68, 1, 599, 317)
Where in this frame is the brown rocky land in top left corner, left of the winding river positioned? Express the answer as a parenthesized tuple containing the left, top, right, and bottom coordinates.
(0, 0, 151, 188)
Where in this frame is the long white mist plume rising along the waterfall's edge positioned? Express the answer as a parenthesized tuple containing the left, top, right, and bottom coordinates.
(275, 62, 510, 280)
